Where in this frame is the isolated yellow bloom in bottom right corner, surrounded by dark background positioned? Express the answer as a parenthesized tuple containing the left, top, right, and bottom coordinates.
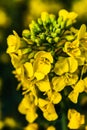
(68, 109, 85, 129)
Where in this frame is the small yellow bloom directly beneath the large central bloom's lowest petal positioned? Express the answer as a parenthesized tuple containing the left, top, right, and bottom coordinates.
(36, 77, 51, 92)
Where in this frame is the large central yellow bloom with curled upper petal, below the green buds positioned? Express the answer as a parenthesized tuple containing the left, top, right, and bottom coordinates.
(33, 51, 53, 80)
